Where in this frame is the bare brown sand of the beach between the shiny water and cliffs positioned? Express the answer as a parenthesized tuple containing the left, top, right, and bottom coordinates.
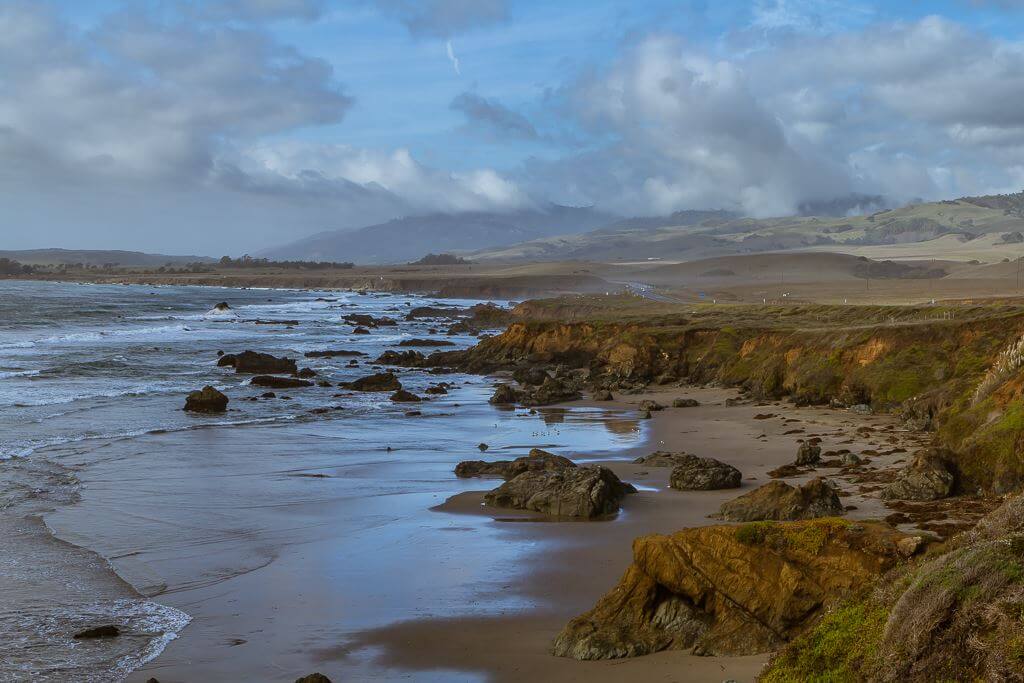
(350, 388, 921, 682)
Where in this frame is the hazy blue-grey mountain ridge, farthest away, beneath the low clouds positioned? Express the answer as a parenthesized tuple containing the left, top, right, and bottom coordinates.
(260, 205, 617, 263)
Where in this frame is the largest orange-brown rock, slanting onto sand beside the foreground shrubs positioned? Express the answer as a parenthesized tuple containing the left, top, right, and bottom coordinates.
(552, 519, 904, 659)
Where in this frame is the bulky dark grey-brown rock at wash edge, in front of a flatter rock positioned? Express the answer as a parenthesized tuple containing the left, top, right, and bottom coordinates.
(483, 465, 636, 519)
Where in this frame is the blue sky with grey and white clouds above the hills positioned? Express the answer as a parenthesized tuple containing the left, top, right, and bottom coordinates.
(0, 0, 1024, 256)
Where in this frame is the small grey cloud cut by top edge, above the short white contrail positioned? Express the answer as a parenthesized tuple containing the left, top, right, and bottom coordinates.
(376, 0, 508, 40)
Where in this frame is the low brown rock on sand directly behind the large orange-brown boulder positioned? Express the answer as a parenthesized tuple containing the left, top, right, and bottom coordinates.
(717, 478, 843, 522)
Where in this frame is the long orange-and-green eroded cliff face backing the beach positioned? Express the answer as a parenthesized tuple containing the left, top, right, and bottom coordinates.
(431, 304, 1024, 493)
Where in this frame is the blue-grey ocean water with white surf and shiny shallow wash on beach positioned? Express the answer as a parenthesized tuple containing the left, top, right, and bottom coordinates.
(0, 281, 642, 681)
